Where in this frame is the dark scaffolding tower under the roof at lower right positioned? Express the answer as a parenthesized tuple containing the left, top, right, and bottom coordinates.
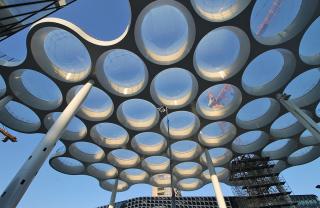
(230, 154, 296, 208)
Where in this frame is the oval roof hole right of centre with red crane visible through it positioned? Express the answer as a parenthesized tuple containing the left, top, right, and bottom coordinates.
(196, 84, 242, 120)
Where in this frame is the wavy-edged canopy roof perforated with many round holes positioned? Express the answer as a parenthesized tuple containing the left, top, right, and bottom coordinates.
(0, 0, 320, 191)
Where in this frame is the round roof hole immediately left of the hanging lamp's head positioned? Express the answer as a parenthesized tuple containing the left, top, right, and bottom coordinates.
(117, 99, 159, 131)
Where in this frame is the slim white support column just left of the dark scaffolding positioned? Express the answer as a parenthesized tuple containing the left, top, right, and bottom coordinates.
(204, 148, 227, 208)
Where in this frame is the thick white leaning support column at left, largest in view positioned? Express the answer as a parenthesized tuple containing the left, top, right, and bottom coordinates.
(0, 81, 93, 208)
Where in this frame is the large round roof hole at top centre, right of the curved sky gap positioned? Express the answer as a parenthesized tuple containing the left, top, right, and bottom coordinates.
(135, 0, 195, 65)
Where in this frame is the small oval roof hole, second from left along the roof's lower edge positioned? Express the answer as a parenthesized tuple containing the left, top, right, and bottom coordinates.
(87, 163, 118, 180)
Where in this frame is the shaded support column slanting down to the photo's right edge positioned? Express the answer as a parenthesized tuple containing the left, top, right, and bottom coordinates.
(277, 94, 320, 141)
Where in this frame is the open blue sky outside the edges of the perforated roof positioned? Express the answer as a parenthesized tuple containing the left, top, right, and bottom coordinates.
(0, 0, 320, 208)
